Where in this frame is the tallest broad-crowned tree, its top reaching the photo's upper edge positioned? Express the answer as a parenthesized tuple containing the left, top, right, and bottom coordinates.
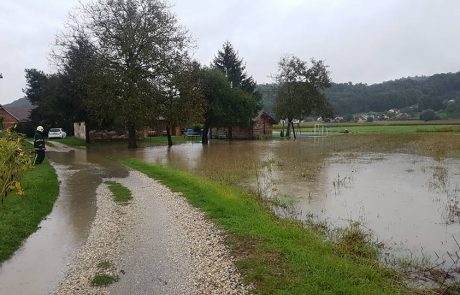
(72, 0, 189, 148)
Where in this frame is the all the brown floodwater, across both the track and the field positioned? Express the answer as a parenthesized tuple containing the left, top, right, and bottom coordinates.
(0, 136, 460, 294)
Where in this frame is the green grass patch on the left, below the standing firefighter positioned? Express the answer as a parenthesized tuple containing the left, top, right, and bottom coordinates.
(0, 160, 59, 263)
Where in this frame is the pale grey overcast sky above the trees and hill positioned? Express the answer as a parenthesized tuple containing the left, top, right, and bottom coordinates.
(0, 0, 460, 104)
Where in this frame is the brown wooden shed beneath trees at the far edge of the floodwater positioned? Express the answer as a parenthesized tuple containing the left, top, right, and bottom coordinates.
(211, 111, 277, 139)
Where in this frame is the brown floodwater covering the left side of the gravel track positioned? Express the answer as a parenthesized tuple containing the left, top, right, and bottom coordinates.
(0, 150, 127, 295)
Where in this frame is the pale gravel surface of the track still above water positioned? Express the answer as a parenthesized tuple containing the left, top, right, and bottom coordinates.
(56, 171, 250, 294)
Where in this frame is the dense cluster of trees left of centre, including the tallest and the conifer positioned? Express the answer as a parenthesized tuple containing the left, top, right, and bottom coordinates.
(24, 0, 261, 148)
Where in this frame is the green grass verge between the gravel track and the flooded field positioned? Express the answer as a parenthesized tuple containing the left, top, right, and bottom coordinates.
(124, 160, 405, 294)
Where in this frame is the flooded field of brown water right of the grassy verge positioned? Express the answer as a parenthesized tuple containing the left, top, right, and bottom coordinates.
(127, 136, 460, 269)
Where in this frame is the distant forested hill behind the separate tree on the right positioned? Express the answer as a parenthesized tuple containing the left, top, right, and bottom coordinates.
(258, 72, 460, 115)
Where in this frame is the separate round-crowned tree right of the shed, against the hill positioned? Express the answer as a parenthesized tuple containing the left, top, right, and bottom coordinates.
(274, 56, 332, 138)
